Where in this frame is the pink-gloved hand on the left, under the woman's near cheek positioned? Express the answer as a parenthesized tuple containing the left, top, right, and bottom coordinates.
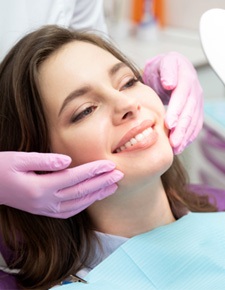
(0, 152, 123, 218)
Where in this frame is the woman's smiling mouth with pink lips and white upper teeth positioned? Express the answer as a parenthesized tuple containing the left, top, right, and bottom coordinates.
(113, 120, 157, 153)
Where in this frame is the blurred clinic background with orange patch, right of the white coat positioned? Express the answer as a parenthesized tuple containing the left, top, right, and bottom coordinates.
(104, 0, 225, 188)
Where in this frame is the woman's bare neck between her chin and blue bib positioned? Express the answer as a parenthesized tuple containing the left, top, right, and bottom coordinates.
(88, 180, 175, 238)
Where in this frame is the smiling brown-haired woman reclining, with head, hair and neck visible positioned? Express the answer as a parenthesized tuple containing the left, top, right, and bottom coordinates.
(0, 26, 219, 289)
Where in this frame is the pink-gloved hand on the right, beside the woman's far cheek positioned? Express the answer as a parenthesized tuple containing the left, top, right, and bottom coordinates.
(143, 52, 203, 154)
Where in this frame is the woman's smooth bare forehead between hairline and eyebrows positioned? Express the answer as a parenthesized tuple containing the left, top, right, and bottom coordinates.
(38, 41, 124, 117)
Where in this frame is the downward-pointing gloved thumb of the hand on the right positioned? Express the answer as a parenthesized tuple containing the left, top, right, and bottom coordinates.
(160, 53, 179, 90)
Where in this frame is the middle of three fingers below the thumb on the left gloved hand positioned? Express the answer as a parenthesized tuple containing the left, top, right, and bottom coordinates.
(55, 170, 124, 201)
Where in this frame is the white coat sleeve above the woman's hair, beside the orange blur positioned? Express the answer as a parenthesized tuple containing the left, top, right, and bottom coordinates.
(70, 0, 108, 33)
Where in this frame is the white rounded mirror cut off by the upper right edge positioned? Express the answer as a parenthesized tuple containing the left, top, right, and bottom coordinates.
(199, 8, 225, 84)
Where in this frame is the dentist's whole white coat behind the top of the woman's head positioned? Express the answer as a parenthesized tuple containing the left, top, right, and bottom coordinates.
(0, 0, 108, 61)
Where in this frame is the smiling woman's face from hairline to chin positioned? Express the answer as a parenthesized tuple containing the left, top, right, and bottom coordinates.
(39, 41, 173, 188)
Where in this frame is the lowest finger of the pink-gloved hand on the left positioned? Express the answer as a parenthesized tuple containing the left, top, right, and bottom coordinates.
(60, 184, 118, 215)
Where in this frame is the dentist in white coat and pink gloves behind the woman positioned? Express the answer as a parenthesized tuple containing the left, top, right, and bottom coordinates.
(0, 0, 203, 218)
